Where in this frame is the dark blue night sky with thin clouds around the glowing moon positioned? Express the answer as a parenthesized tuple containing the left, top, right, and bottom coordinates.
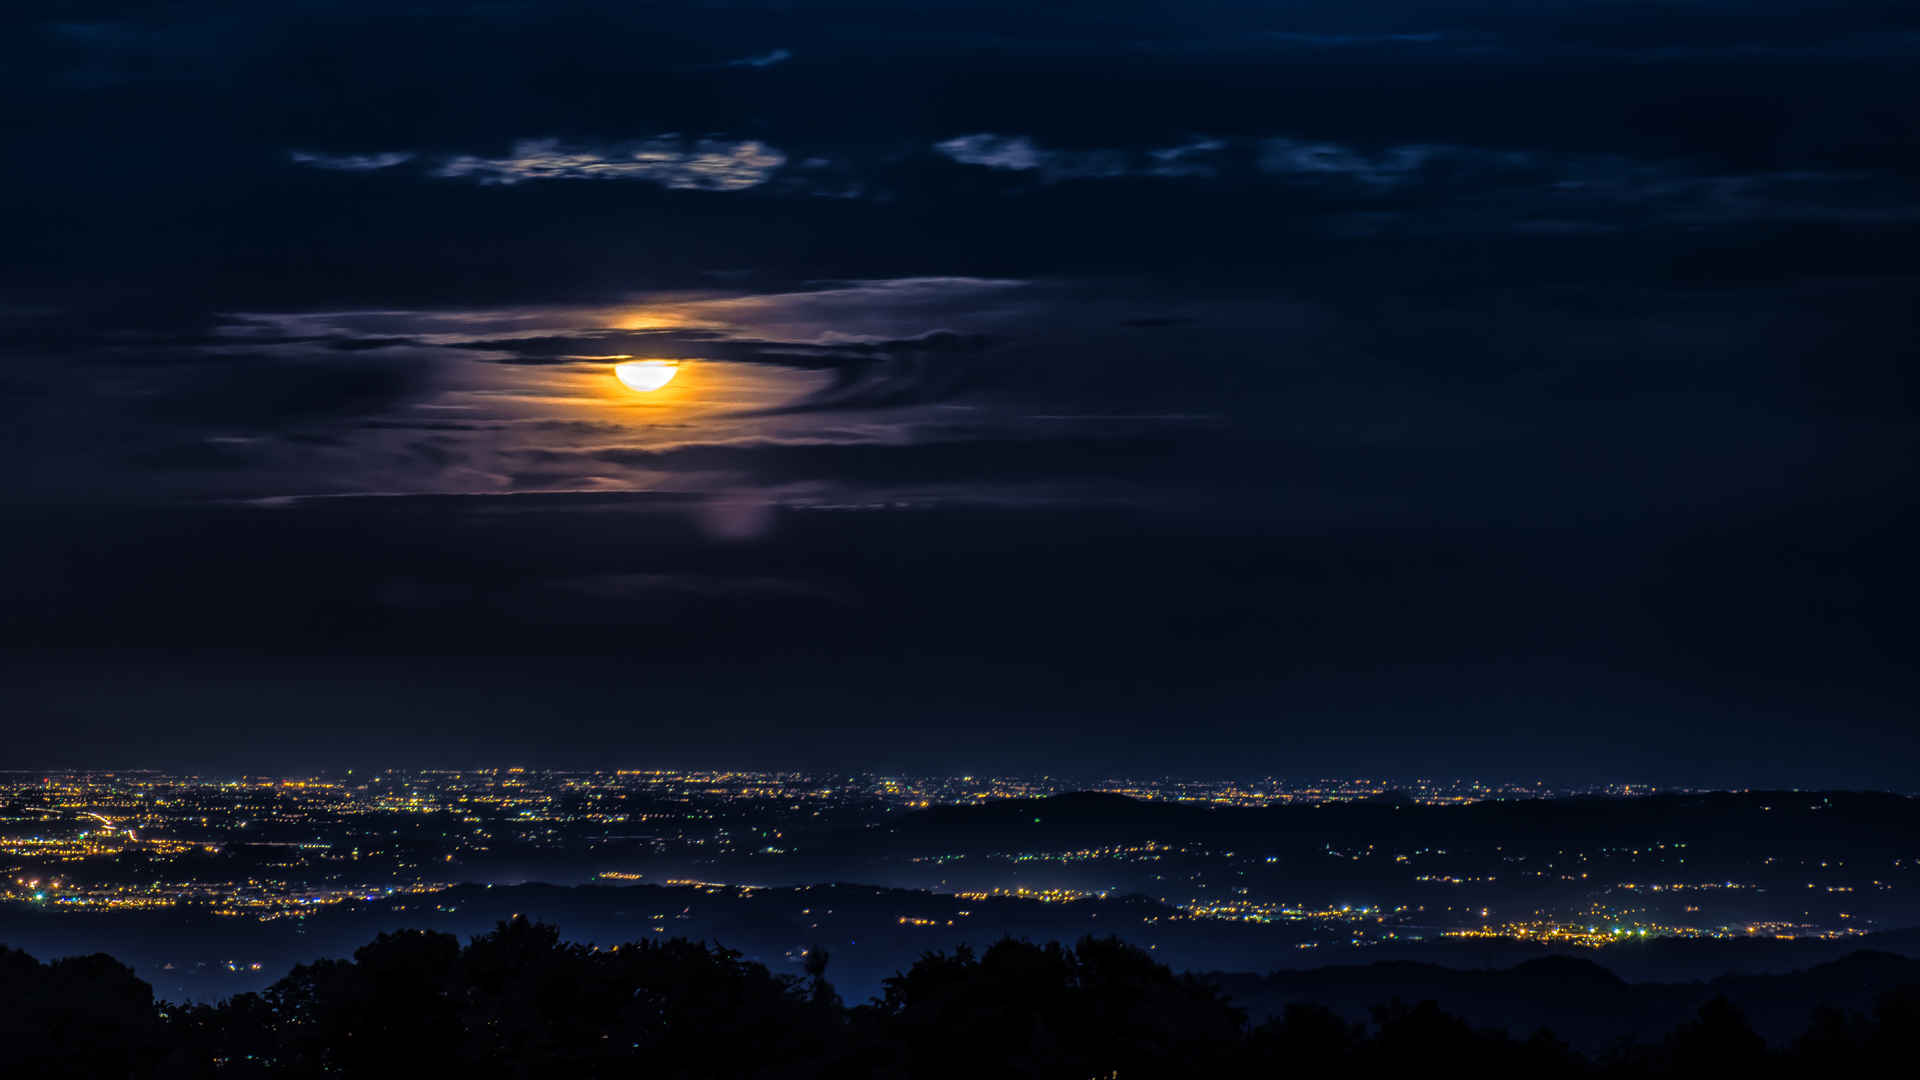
(0, 0, 1920, 790)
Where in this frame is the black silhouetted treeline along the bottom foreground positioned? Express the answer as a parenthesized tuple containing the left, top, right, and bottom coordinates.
(0, 919, 1920, 1080)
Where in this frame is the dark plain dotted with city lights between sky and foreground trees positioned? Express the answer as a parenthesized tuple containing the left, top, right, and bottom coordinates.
(0, 767, 1920, 994)
